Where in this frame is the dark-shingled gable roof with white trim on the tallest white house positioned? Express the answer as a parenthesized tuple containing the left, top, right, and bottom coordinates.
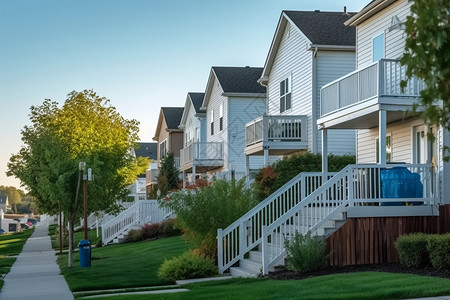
(258, 11, 356, 84)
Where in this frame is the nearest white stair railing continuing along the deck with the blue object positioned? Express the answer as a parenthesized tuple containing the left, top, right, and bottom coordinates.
(262, 165, 437, 274)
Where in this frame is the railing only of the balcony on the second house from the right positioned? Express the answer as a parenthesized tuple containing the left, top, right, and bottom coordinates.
(245, 116, 307, 146)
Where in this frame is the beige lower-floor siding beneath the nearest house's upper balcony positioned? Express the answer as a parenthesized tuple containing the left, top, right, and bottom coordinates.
(357, 119, 423, 163)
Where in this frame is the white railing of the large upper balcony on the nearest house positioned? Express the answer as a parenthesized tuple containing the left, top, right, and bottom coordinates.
(320, 59, 425, 116)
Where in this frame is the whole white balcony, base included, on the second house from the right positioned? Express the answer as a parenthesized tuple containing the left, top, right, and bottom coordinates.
(245, 115, 308, 155)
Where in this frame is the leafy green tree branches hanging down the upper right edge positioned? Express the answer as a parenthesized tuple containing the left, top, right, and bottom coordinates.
(401, 0, 450, 158)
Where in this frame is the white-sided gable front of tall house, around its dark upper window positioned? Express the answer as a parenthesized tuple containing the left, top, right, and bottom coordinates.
(267, 18, 312, 150)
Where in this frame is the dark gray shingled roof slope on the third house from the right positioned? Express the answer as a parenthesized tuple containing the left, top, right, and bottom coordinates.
(213, 67, 266, 94)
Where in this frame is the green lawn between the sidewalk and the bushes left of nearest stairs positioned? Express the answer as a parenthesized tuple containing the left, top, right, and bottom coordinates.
(58, 236, 190, 291)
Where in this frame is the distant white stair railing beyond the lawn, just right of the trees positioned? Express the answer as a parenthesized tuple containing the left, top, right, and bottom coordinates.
(102, 200, 172, 245)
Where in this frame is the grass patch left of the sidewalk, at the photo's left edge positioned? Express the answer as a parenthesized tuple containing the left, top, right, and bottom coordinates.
(0, 227, 34, 289)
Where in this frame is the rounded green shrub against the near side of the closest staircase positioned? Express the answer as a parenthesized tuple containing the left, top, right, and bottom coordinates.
(284, 232, 329, 273)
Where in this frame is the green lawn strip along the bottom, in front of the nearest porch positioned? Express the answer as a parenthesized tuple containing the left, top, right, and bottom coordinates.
(102, 272, 450, 300)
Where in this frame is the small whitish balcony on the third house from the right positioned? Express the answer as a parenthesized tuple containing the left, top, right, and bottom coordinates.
(180, 142, 223, 173)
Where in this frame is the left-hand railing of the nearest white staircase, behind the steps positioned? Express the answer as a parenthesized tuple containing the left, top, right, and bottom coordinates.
(217, 172, 334, 273)
